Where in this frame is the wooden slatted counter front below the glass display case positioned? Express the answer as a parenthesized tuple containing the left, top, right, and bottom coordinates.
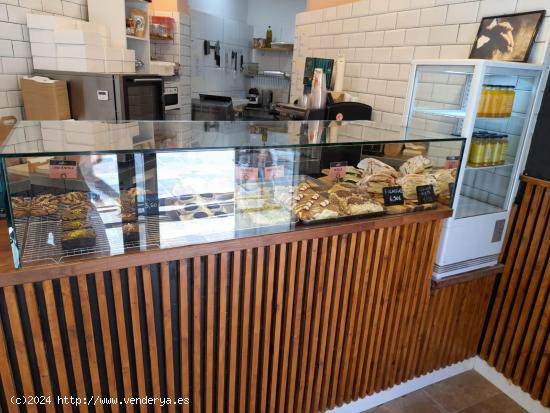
(0, 209, 494, 412)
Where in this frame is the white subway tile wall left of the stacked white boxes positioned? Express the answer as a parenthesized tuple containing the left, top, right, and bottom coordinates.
(0, 0, 88, 119)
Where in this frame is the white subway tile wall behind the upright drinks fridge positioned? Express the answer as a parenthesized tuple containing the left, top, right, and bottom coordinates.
(291, 0, 550, 125)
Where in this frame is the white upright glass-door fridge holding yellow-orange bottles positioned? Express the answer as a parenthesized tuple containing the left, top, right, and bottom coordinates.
(403, 59, 547, 279)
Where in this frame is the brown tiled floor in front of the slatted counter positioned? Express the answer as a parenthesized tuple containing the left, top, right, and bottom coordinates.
(365, 371, 526, 413)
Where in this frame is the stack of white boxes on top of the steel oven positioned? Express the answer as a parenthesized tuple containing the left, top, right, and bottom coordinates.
(27, 14, 136, 73)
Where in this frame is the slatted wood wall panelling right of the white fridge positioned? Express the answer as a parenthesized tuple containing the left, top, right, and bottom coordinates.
(480, 177, 550, 407)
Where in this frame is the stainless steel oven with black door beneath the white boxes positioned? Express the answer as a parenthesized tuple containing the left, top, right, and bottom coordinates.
(36, 71, 164, 121)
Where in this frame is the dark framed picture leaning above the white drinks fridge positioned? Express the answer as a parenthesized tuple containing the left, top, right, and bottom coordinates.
(470, 10, 545, 62)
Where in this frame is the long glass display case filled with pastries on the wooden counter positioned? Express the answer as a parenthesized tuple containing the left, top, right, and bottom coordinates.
(0, 121, 465, 267)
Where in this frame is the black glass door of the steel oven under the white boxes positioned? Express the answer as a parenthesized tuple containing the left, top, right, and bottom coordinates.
(121, 75, 164, 120)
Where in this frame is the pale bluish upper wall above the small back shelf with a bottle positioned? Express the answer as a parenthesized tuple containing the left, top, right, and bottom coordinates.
(248, 0, 307, 43)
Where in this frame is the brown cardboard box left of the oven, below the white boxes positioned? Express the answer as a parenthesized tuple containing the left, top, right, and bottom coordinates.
(21, 79, 71, 120)
